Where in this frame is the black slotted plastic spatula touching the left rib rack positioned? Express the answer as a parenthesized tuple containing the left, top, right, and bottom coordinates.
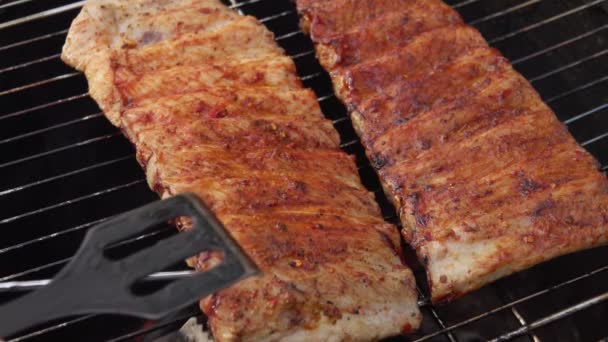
(0, 194, 258, 338)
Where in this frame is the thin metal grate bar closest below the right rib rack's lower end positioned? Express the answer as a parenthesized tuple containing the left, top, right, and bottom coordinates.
(416, 265, 608, 342)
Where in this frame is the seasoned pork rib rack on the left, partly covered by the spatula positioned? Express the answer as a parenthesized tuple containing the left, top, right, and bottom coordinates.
(62, 0, 421, 341)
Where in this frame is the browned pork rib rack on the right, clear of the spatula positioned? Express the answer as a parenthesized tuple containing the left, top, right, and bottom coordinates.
(297, 0, 608, 301)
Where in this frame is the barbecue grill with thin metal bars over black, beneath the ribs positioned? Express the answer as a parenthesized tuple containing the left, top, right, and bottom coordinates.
(0, 0, 608, 342)
